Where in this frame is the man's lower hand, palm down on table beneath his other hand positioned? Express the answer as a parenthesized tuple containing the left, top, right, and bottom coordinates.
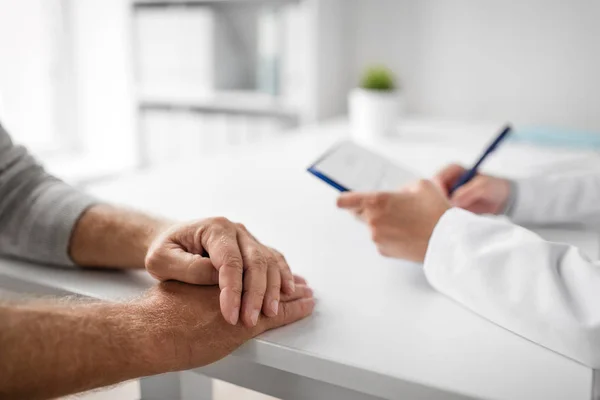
(140, 277, 315, 373)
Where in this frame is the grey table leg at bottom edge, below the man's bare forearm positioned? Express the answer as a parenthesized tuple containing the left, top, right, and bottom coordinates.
(140, 372, 213, 400)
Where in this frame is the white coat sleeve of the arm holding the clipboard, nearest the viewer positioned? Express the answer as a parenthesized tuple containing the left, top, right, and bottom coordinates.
(424, 209, 600, 369)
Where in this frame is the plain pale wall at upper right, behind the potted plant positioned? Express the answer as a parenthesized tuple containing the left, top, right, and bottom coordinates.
(347, 0, 600, 130)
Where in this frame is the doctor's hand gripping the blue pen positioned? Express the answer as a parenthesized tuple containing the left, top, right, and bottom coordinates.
(433, 164, 511, 214)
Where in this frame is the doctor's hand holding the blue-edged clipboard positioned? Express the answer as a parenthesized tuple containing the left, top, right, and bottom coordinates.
(338, 180, 451, 262)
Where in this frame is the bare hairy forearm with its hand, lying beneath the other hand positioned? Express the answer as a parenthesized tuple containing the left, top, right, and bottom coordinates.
(0, 278, 315, 400)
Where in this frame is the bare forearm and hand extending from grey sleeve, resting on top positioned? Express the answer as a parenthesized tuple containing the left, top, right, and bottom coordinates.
(70, 204, 302, 327)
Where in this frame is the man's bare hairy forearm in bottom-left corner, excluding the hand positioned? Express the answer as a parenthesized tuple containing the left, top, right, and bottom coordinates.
(0, 302, 168, 399)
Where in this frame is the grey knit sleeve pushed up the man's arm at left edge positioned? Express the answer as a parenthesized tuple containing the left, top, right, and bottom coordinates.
(0, 125, 96, 265)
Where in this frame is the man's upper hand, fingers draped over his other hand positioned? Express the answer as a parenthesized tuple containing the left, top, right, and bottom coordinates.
(145, 218, 295, 327)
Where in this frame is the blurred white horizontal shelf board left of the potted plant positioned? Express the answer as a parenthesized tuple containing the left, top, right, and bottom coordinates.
(139, 90, 299, 120)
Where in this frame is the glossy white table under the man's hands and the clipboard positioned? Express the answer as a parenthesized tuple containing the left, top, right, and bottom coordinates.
(0, 122, 600, 400)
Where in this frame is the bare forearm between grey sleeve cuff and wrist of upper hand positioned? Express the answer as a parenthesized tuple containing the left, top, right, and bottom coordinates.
(69, 205, 169, 268)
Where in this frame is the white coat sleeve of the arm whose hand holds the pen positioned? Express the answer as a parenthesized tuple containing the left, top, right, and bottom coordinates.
(508, 173, 600, 226)
